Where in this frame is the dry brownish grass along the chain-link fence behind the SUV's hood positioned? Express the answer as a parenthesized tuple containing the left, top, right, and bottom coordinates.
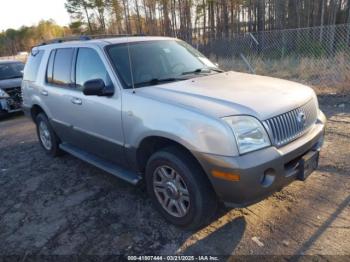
(212, 51, 350, 93)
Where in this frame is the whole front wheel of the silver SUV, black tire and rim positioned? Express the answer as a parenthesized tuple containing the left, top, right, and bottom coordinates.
(145, 147, 218, 229)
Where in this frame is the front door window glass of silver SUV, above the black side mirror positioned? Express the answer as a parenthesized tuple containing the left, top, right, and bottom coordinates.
(75, 48, 111, 89)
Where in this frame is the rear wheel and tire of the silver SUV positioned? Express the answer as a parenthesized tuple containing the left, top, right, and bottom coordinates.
(35, 113, 62, 157)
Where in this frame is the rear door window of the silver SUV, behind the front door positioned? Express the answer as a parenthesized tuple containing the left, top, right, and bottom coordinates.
(47, 48, 74, 86)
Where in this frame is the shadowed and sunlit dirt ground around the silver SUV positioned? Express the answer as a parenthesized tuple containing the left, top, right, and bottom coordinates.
(0, 95, 350, 258)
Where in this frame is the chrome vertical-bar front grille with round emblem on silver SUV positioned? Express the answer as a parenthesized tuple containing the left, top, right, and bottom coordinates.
(264, 100, 317, 147)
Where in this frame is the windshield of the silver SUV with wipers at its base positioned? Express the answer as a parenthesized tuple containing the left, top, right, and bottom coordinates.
(107, 40, 220, 88)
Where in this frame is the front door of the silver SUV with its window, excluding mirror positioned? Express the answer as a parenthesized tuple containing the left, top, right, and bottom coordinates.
(67, 48, 126, 165)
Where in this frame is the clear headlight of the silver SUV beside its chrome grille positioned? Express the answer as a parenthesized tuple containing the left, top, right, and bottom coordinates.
(223, 116, 271, 154)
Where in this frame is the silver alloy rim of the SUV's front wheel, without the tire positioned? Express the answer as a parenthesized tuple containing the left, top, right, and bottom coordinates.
(153, 166, 190, 217)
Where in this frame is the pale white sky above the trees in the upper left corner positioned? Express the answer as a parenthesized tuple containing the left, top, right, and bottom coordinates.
(0, 0, 70, 32)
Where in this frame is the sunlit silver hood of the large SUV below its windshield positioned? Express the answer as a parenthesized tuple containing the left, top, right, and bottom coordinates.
(137, 72, 315, 120)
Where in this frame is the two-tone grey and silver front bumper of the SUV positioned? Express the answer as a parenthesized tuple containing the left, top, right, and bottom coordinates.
(195, 112, 326, 207)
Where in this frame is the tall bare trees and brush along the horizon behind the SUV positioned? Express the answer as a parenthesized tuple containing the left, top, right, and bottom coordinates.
(0, 0, 350, 55)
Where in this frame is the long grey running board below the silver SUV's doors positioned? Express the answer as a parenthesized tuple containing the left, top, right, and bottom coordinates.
(60, 143, 142, 185)
